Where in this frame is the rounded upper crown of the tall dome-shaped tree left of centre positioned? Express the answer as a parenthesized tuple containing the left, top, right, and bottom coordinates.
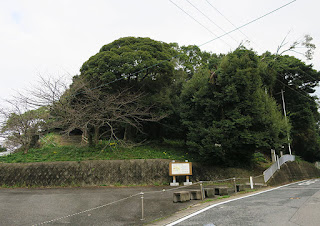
(80, 37, 177, 94)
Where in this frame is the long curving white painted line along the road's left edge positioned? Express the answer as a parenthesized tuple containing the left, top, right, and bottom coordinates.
(166, 181, 307, 226)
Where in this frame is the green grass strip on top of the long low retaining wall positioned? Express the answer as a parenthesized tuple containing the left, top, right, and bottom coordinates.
(0, 136, 195, 163)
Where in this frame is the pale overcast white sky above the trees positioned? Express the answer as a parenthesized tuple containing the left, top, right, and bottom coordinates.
(0, 0, 320, 103)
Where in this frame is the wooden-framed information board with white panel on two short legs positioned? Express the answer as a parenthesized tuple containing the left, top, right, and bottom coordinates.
(169, 160, 192, 186)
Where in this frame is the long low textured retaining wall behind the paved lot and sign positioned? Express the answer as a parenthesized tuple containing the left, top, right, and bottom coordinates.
(0, 159, 253, 186)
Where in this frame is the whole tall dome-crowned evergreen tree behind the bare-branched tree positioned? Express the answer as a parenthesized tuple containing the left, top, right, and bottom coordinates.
(74, 37, 184, 141)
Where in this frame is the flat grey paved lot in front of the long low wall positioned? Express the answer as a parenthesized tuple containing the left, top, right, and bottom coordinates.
(0, 185, 204, 226)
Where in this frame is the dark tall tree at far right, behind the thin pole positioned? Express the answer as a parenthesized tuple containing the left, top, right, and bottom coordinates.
(266, 56, 320, 161)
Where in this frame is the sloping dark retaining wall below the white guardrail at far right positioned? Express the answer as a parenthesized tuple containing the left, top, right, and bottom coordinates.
(268, 162, 320, 185)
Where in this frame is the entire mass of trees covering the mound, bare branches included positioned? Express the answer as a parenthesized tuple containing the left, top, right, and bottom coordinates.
(1, 37, 320, 165)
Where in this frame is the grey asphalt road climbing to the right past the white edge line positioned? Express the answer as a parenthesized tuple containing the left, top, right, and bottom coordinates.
(168, 179, 320, 226)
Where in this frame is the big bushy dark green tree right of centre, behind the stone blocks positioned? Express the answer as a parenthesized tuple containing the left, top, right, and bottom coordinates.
(181, 49, 287, 165)
